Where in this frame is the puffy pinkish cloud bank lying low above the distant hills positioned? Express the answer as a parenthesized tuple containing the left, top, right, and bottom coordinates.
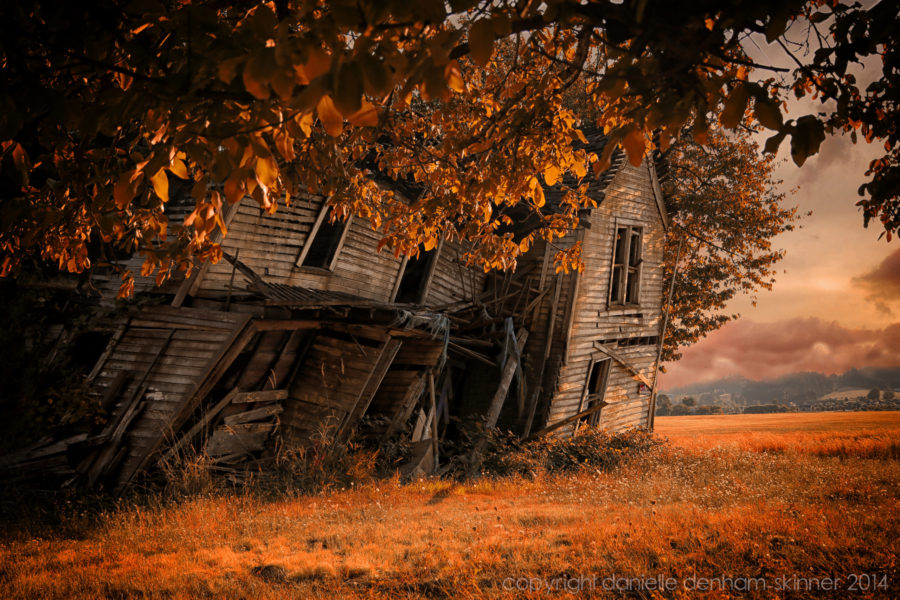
(660, 318, 900, 389)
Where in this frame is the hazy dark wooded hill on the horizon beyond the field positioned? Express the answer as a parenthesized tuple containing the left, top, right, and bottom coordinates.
(661, 367, 900, 405)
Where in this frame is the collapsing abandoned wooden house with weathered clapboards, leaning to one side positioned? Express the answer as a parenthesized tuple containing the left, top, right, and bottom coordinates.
(0, 133, 667, 489)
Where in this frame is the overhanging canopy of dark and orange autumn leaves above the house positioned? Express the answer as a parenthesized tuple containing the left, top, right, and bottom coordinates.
(0, 0, 900, 300)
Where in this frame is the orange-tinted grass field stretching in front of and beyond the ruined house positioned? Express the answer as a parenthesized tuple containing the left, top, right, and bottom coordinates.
(0, 413, 900, 599)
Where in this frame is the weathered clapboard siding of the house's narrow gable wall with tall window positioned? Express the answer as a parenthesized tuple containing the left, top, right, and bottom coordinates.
(548, 159, 665, 430)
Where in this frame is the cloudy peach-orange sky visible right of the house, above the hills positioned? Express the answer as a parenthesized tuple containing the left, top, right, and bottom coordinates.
(660, 30, 900, 390)
